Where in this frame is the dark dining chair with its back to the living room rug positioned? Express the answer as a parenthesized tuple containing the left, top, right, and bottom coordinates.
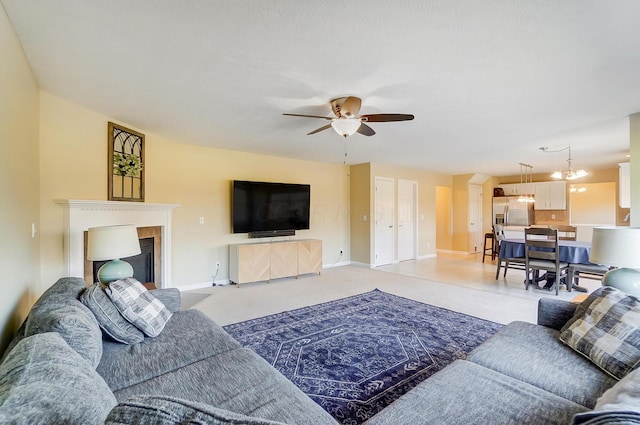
(524, 228, 571, 295)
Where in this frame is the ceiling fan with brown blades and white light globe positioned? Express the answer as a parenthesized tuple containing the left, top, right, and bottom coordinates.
(282, 96, 413, 138)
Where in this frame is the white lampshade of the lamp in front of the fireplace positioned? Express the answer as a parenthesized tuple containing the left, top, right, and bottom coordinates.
(87, 225, 140, 261)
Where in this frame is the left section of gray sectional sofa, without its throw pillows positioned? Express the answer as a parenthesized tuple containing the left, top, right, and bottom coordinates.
(0, 278, 337, 425)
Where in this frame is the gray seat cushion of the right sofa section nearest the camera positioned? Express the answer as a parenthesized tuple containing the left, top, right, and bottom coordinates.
(367, 360, 587, 425)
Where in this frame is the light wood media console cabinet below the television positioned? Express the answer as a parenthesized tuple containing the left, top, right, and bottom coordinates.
(229, 239, 322, 287)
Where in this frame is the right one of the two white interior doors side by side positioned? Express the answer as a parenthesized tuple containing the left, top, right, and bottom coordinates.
(398, 180, 418, 261)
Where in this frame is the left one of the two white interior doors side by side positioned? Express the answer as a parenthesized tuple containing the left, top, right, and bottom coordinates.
(373, 177, 395, 266)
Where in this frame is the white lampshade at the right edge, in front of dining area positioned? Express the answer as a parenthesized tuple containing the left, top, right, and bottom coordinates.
(589, 227, 640, 269)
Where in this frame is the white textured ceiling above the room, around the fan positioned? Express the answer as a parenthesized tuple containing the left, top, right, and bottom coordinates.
(0, 0, 640, 175)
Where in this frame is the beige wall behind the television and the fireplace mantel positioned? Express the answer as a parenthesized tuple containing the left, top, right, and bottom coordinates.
(40, 92, 350, 287)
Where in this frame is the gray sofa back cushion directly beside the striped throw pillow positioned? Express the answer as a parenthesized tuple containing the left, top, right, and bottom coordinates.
(25, 277, 102, 368)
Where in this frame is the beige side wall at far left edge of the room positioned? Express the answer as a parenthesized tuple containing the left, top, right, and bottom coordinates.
(0, 7, 40, 353)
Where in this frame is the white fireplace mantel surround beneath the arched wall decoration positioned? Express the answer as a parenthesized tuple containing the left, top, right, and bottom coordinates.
(55, 199, 178, 288)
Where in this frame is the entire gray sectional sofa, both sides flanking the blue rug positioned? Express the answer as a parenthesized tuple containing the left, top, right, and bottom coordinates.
(0, 278, 640, 425)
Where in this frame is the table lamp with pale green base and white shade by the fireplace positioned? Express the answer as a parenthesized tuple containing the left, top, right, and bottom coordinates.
(87, 225, 140, 285)
